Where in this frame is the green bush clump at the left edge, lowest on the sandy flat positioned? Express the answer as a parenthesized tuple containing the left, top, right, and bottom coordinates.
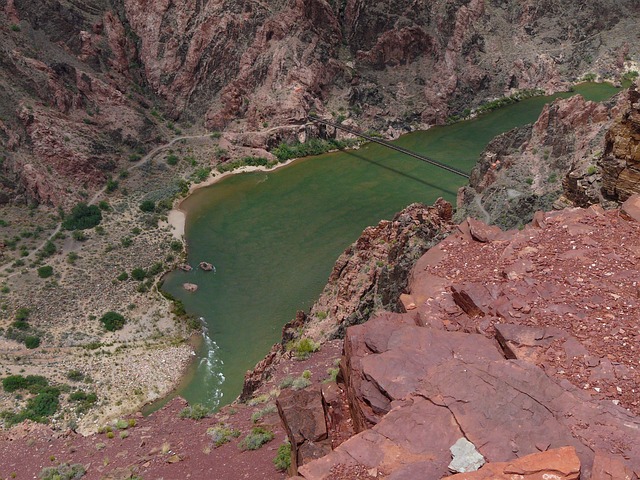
(0, 375, 60, 426)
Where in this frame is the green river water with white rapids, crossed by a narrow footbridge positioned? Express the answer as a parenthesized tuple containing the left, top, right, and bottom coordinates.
(163, 84, 618, 407)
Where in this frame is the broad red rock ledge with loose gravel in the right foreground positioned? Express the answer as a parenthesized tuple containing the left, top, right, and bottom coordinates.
(298, 197, 640, 480)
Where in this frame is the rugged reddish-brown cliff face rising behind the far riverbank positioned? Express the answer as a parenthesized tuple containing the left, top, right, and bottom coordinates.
(0, 0, 639, 203)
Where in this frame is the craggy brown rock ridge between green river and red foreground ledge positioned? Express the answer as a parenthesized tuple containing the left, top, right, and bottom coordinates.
(305, 199, 453, 340)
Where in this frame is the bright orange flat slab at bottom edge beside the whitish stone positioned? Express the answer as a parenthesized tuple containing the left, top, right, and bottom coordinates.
(442, 447, 580, 480)
